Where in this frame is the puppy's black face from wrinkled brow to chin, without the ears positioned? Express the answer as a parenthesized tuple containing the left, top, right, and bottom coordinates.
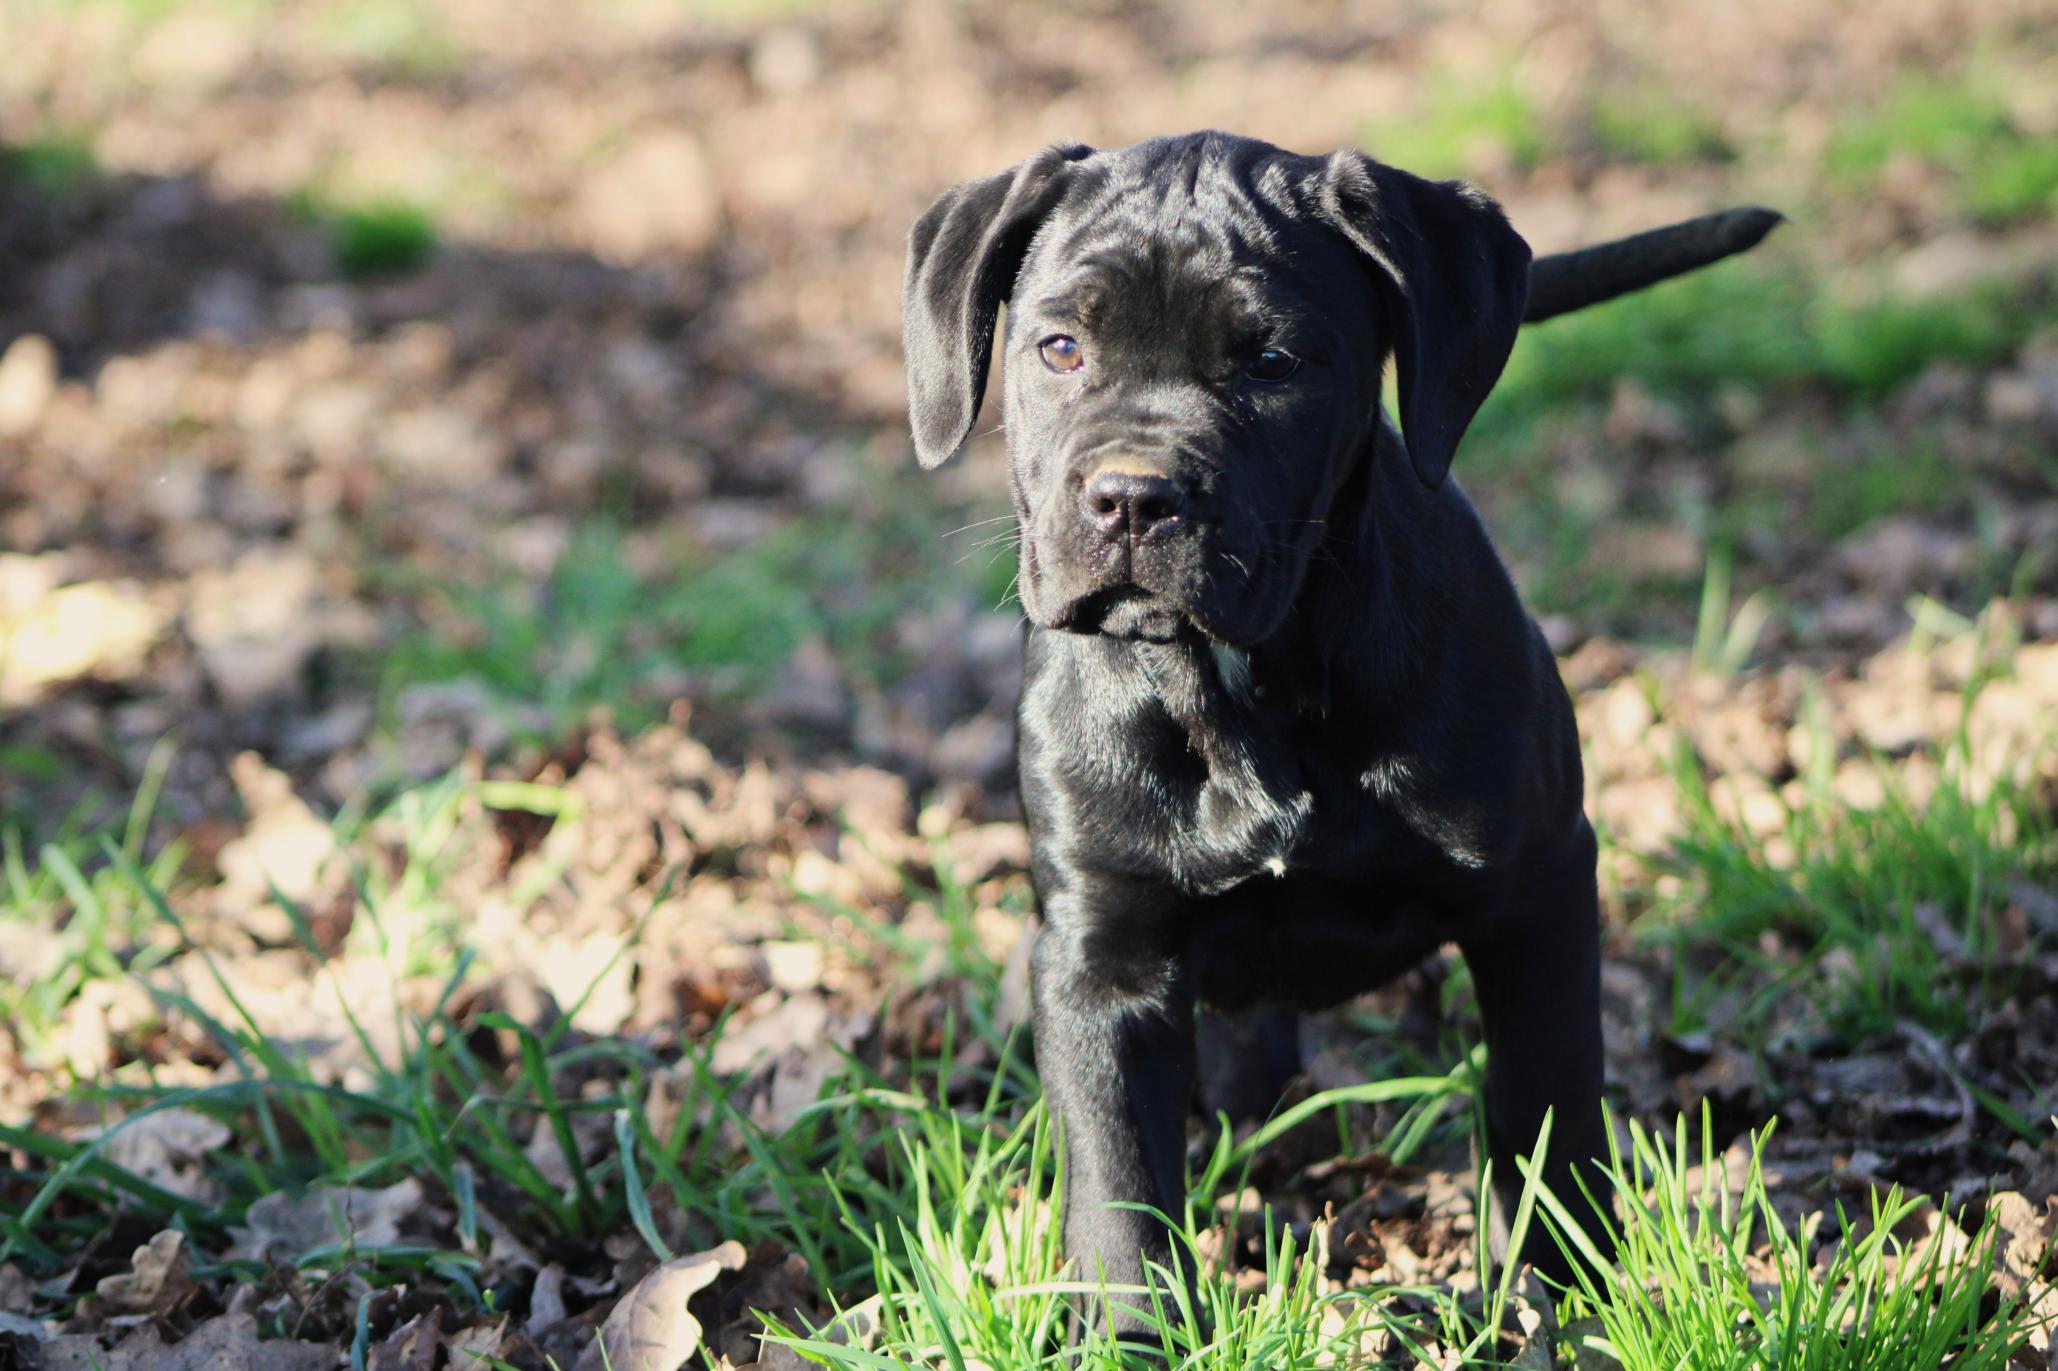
(1008, 134, 1377, 646)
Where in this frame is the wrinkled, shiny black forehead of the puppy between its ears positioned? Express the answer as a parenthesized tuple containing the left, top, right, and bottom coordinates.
(1017, 144, 1350, 321)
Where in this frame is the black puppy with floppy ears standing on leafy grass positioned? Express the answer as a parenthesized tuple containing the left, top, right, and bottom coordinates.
(903, 134, 1778, 1328)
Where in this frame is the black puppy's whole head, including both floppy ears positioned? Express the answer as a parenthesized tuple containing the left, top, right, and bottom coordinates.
(901, 134, 1529, 646)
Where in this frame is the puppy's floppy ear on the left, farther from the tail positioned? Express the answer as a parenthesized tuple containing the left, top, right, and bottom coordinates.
(901, 142, 1093, 467)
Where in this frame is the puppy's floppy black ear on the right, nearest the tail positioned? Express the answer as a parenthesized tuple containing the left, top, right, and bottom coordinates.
(1321, 148, 1529, 488)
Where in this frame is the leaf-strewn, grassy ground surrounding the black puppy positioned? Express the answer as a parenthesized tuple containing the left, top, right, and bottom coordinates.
(0, 0, 2058, 1371)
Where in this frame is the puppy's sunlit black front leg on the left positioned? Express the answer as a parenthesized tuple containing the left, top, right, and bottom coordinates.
(1031, 879, 1194, 1334)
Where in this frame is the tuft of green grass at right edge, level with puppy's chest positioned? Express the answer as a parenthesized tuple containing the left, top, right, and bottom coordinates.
(1646, 658, 2058, 1042)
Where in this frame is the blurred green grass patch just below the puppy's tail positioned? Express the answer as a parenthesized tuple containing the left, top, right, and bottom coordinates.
(1457, 250, 2058, 617)
